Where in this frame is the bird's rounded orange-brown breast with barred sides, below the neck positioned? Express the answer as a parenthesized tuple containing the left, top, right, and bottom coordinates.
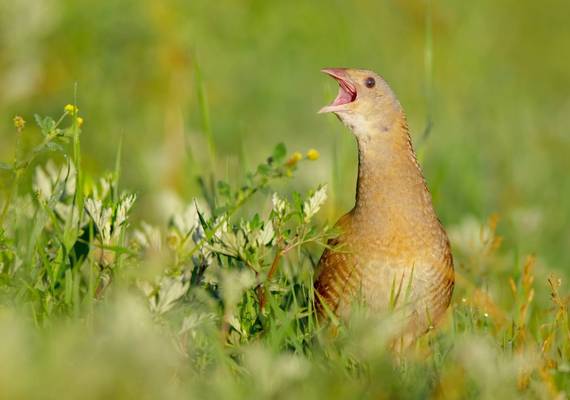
(316, 221, 453, 326)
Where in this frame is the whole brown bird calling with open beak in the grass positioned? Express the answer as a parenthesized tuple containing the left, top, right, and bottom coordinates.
(314, 68, 455, 346)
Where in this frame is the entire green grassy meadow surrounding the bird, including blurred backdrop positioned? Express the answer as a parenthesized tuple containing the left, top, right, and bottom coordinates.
(0, 0, 570, 399)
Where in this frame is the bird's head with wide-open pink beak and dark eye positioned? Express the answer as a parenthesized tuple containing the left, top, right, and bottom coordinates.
(319, 68, 402, 136)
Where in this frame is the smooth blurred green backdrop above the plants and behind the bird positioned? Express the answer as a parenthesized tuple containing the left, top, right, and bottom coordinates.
(0, 0, 570, 270)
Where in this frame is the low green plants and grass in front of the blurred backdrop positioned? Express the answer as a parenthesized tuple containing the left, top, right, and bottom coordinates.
(0, 105, 570, 399)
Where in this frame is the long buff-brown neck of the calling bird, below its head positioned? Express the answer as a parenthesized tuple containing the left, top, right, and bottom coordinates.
(353, 113, 437, 231)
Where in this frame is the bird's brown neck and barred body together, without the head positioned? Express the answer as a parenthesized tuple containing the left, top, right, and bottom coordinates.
(315, 112, 454, 340)
